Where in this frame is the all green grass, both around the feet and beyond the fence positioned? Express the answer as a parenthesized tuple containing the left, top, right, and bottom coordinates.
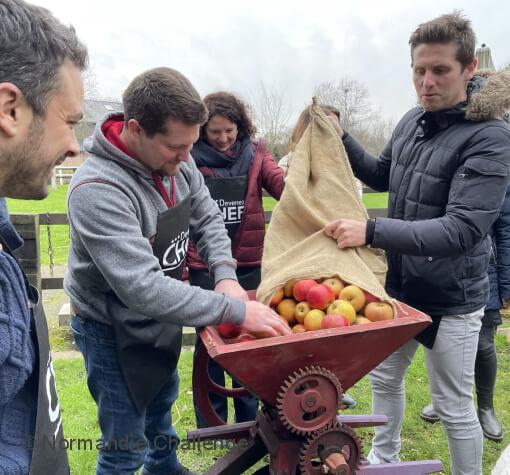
(4, 186, 510, 475)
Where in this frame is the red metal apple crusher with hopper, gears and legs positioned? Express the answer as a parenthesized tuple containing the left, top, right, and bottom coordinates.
(188, 296, 442, 475)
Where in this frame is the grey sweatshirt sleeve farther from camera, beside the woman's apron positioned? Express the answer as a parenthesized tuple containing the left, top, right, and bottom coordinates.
(186, 158, 237, 283)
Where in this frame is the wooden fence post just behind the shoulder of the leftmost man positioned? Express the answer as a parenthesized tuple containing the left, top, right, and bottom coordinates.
(10, 214, 41, 291)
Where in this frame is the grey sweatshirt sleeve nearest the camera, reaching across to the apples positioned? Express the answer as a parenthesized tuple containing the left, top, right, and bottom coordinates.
(68, 182, 246, 326)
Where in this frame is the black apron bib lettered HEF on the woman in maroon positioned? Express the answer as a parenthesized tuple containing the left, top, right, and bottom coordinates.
(204, 176, 248, 241)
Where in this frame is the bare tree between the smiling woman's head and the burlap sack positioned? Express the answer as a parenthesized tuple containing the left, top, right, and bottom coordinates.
(251, 82, 290, 158)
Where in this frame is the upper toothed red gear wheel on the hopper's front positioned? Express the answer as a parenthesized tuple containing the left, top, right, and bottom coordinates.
(276, 366, 343, 435)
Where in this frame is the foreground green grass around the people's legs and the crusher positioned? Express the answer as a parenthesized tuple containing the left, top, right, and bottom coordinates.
(55, 335, 510, 475)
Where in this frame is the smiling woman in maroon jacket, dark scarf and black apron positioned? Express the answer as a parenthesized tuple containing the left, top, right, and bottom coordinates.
(187, 92, 284, 428)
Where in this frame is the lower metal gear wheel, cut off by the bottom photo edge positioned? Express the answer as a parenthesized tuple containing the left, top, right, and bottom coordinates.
(299, 422, 364, 475)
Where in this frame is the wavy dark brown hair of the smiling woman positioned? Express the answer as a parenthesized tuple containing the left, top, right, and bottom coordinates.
(200, 91, 257, 140)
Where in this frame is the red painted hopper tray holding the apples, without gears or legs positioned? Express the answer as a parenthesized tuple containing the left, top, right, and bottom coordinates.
(200, 303, 431, 406)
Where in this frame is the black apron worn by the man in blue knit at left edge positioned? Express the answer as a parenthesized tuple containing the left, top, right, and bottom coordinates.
(0, 237, 70, 475)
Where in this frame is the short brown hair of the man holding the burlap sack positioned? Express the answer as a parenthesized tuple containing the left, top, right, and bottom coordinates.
(409, 10, 476, 68)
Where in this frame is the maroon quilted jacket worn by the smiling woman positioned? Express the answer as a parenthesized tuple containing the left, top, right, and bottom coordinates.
(188, 141, 284, 269)
